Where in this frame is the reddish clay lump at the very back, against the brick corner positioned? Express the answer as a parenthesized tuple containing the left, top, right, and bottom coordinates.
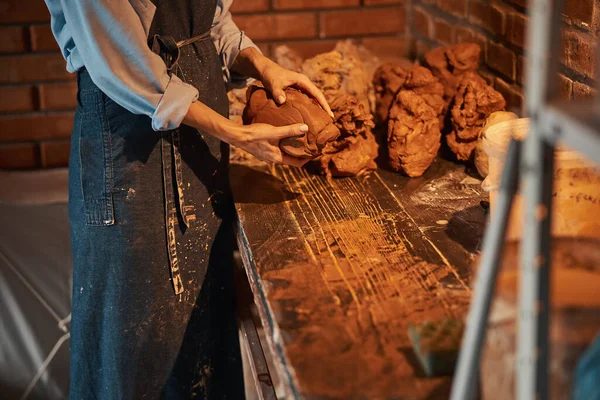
(424, 43, 481, 102)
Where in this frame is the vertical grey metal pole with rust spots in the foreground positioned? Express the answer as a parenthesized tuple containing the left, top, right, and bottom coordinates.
(515, 0, 563, 400)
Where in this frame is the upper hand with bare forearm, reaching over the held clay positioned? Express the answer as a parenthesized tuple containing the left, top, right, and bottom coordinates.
(232, 47, 334, 118)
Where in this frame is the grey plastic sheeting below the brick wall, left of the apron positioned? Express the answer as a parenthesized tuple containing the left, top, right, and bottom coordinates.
(0, 171, 73, 400)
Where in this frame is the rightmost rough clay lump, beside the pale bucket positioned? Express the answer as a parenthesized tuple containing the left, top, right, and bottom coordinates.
(446, 72, 506, 161)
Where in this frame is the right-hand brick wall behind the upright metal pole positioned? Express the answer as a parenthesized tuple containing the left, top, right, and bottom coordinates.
(409, 0, 600, 111)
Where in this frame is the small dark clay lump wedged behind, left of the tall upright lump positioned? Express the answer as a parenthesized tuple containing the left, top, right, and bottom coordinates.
(373, 63, 407, 124)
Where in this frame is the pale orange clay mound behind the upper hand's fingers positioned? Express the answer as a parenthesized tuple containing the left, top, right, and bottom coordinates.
(302, 42, 375, 112)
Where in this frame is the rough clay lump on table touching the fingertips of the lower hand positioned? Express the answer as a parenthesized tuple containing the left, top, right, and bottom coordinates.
(308, 94, 378, 176)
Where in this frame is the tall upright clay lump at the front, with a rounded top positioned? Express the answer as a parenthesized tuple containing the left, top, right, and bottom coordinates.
(388, 90, 441, 177)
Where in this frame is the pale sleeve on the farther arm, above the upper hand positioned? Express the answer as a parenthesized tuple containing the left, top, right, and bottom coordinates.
(211, 0, 260, 90)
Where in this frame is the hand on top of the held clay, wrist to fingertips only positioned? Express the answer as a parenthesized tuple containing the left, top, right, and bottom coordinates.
(260, 62, 334, 118)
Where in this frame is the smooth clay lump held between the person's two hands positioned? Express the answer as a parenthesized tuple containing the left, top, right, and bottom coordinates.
(243, 86, 340, 159)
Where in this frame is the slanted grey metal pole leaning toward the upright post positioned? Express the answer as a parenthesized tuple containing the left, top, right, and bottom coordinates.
(450, 139, 522, 400)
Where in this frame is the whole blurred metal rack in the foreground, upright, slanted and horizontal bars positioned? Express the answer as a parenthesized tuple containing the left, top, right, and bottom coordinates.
(451, 0, 600, 400)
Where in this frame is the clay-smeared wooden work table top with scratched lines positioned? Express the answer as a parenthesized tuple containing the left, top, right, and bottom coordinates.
(231, 156, 487, 399)
